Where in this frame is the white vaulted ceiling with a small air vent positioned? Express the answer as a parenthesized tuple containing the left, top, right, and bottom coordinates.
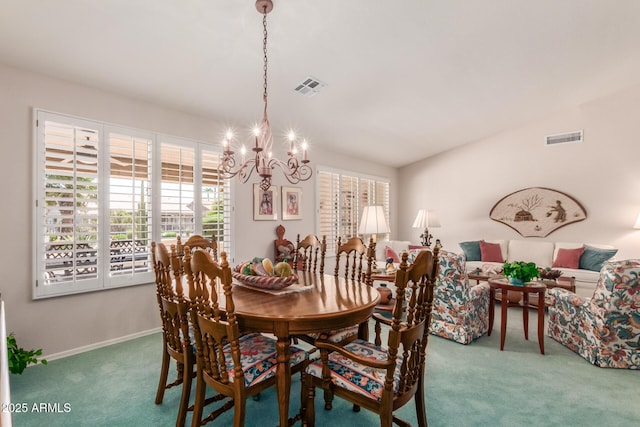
(0, 0, 640, 167)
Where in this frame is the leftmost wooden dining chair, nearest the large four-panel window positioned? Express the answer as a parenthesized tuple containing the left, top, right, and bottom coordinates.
(151, 242, 196, 426)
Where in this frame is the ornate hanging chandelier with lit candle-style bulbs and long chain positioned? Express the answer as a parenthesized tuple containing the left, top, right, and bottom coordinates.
(218, 0, 312, 191)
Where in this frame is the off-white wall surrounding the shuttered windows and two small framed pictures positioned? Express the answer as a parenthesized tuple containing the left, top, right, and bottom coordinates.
(0, 64, 397, 355)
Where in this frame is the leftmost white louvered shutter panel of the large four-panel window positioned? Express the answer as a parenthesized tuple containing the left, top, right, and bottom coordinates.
(35, 113, 102, 296)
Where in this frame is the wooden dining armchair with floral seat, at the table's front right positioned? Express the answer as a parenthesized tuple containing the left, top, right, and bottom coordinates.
(302, 248, 438, 427)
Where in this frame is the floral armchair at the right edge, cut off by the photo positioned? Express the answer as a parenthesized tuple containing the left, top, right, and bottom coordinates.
(547, 259, 640, 369)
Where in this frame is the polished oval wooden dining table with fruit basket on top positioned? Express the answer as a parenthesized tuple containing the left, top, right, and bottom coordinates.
(215, 271, 380, 426)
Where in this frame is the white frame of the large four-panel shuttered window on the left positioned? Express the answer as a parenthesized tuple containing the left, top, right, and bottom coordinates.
(32, 108, 234, 300)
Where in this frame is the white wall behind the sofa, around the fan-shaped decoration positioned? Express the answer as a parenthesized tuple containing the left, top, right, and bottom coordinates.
(398, 82, 640, 259)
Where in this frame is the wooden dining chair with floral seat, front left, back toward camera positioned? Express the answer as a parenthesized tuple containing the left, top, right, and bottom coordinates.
(184, 250, 309, 427)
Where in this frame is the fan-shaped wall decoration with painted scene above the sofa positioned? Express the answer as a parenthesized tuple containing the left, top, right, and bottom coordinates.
(489, 187, 587, 237)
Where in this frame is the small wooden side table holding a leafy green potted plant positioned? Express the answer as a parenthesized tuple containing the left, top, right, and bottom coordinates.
(487, 278, 547, 354)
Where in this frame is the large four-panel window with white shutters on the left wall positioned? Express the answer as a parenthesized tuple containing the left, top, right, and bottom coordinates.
(34, 110, 231, 298)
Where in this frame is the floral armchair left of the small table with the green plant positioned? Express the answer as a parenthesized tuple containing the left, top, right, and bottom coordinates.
(429, 250, 489, 344)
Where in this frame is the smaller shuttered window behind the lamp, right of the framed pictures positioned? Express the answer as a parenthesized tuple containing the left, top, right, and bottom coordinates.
(316, 167, 389, 252)
